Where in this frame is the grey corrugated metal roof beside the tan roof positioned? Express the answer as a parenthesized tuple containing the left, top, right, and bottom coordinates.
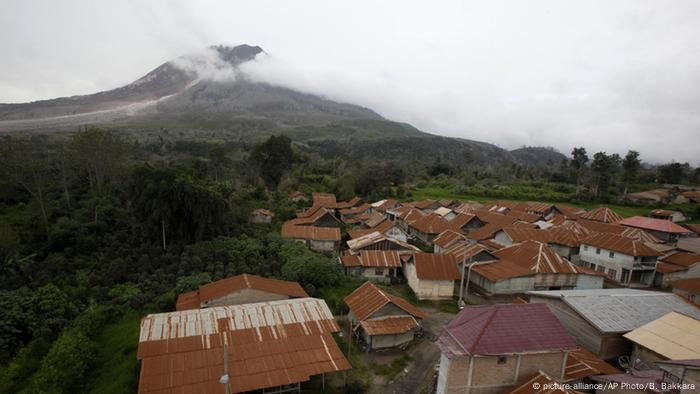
(528, 289, 700, 332)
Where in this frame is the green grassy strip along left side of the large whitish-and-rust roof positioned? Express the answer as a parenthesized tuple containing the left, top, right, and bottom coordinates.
(87, 310, 141, 394)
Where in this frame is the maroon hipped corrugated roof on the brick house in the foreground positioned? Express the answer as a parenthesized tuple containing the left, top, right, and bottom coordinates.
(438, 303, 578, 357)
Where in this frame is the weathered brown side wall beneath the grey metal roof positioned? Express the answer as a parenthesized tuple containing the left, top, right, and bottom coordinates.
(530, 295, 602, 357)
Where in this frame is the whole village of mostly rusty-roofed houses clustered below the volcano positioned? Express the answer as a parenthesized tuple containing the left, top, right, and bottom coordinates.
(137, 192, 700, 394)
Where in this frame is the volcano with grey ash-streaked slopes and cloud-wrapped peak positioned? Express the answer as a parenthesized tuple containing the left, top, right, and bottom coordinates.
(0, 45, 564, 166)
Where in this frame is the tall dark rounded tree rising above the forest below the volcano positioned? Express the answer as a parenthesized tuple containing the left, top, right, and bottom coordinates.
(250, 135, 294, 189)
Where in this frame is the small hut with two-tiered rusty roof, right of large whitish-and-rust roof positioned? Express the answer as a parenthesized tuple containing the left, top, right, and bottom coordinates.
(345, 282, 427, 350)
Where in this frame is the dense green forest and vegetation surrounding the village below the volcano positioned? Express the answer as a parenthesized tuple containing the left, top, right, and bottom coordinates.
(0, 127, 700, 393)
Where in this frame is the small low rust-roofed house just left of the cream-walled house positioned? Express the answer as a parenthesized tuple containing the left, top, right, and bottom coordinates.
(338, 250, 401, 283)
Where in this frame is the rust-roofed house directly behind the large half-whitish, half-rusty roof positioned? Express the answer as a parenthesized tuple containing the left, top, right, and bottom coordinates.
(175, 274, 309, 311)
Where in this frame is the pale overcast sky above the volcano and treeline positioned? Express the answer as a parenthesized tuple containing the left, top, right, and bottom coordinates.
(0, 0, 700, 165)
